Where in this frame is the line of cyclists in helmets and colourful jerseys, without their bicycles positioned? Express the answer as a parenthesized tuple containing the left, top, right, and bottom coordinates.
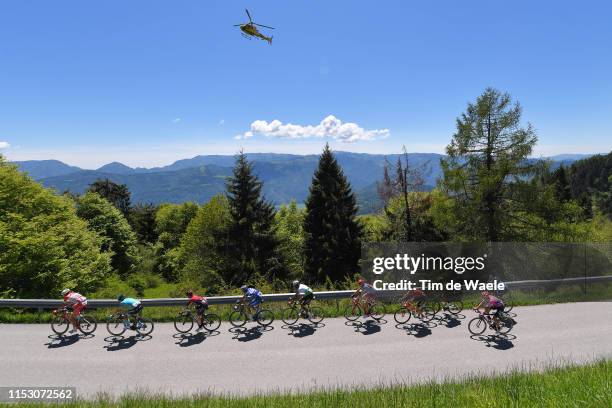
(61, 278, 505, 334)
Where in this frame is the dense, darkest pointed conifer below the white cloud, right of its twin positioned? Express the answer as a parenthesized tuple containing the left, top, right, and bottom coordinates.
(304, 145, 362, 282)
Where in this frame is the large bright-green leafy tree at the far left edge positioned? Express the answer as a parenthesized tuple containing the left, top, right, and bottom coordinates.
(0, 156, 110, 298)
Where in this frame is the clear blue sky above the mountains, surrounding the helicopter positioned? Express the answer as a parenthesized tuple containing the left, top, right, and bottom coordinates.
(0, 0, 612, 168)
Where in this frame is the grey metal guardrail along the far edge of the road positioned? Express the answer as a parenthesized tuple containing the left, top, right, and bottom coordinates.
(0, 275, 612, 310)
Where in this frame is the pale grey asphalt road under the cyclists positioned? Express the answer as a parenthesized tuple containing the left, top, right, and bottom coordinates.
(0, 302, 612, 397)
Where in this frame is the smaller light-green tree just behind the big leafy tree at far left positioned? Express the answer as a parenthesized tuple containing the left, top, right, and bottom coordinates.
(76, 191, 138, 275)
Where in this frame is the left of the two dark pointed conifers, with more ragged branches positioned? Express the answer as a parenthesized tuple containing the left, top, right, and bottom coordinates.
(227, 152, 284, 284)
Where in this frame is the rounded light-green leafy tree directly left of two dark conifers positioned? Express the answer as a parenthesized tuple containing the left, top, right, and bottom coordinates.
(179, 195, 232, 293)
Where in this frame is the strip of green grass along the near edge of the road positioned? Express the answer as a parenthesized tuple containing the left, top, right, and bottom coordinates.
(7, 360, 612, 408)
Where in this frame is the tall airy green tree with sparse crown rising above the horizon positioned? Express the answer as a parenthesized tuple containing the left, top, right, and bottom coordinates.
(440, 88, 537, 241)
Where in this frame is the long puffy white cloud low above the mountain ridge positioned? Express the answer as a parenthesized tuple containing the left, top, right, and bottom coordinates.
(235, 115, 390, 143)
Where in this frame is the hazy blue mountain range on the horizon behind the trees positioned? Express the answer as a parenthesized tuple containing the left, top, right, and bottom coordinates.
(14, 151, 588, 212)
